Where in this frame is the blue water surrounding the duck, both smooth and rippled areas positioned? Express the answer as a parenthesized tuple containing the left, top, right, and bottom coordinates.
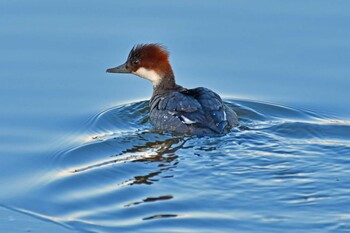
(0, 0, 350, 232)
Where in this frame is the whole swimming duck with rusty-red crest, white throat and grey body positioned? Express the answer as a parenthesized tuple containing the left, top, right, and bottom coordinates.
(107, 44, 238, 136)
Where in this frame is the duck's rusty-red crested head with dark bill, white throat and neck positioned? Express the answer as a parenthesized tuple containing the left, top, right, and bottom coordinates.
(107, 44, 175, 87)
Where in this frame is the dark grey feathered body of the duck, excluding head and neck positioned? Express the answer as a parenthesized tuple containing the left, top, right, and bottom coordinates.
(150, 87, 238, 135)
